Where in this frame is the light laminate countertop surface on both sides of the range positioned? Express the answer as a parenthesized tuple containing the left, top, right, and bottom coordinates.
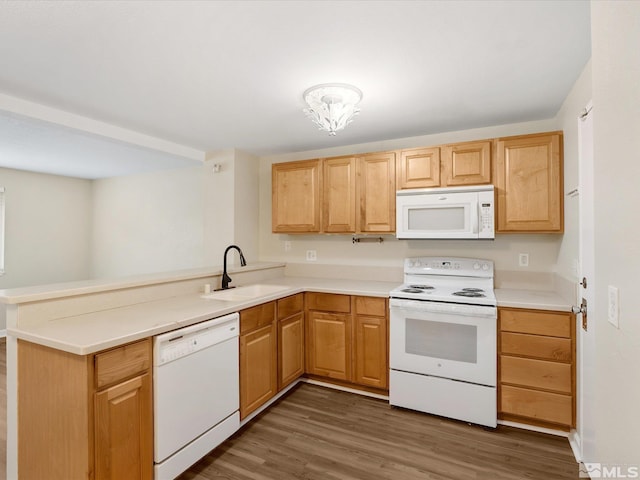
(7, 277, 571, 355)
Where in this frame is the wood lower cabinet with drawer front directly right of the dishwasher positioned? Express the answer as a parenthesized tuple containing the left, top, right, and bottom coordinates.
(240, 302, 278, 419)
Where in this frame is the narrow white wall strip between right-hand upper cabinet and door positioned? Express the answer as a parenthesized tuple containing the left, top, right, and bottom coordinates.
(556, 61, 592, 283)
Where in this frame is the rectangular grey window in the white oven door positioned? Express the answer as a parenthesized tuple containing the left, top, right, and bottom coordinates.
(405, 318, 478, 363)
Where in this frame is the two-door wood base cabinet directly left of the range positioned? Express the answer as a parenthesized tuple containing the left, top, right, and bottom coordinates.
(306, 293, 389, 390)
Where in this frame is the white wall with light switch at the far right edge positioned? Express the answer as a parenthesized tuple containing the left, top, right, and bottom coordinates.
(591, 1, 640, 466)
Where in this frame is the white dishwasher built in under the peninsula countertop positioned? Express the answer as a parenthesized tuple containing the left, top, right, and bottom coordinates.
(153, 313, 240, 480)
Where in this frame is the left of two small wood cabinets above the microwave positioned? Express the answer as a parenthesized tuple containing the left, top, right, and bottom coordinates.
(397, 147, 440, 190)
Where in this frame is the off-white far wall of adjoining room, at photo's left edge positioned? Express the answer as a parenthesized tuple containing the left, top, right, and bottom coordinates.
(0, 168, 92, 330)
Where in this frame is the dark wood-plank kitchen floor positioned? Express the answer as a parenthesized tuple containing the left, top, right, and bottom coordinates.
(0, 339, 578, 480)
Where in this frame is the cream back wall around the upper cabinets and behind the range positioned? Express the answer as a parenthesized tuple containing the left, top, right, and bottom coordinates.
(255, 119, 562, 275)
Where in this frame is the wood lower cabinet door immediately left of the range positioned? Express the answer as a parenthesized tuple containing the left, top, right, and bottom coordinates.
(354, 315, 389, 388)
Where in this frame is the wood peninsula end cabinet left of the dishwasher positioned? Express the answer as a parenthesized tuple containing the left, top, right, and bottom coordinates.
(17, 339, 153, 480)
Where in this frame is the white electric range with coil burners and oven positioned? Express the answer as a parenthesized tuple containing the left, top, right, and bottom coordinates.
(389, 257, 497, 427)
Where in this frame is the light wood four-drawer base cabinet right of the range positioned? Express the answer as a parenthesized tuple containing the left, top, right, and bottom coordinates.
(498, 308, 576, 430)
